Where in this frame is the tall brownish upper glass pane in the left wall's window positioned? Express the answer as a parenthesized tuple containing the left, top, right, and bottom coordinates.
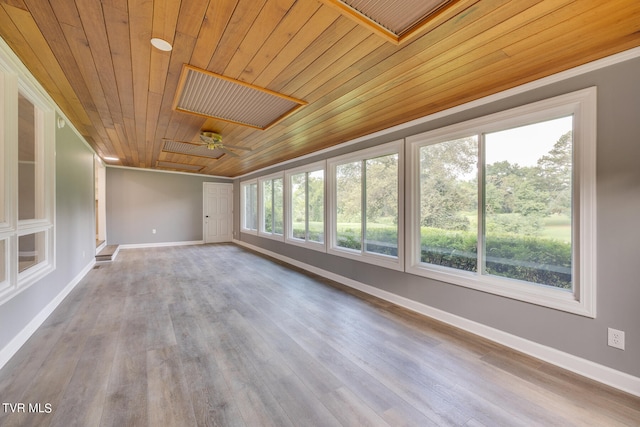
(18, 94, 41, 220)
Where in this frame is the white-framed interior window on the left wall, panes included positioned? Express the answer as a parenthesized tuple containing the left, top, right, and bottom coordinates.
(0, 63, 55, 303)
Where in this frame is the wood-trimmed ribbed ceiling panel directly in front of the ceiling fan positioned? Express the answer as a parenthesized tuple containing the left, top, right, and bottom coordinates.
(173, 64, 307, 130)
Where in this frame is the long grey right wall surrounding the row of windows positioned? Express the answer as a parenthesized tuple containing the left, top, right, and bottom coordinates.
(235, 59, 640, 377)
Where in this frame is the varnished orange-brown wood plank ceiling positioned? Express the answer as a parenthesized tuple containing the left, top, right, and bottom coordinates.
(0, 0, 640, 177)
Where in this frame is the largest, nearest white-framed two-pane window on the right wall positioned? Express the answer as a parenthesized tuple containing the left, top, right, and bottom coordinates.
(408, 89, 595, 316)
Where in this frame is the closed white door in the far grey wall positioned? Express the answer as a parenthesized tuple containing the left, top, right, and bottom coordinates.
(203, 182, 233, 243)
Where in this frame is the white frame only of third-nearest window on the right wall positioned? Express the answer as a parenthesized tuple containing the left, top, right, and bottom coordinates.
(284, 160, 328, 252)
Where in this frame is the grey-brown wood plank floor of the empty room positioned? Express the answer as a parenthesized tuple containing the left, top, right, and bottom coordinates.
(0, 245, 640, 427)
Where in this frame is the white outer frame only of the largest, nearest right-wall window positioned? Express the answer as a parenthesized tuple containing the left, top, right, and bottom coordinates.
(406, 87, 597, 318)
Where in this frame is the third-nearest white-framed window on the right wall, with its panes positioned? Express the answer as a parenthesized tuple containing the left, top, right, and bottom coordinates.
(286, 162, 325, 250)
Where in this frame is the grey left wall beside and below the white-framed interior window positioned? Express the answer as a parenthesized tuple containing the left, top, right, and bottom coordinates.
(0, 112, 95, 349)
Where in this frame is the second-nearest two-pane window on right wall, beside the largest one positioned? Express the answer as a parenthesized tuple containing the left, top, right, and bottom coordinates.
(329, 141, 403, 270)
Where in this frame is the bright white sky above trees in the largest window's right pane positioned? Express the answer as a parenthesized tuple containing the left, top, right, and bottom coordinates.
(485, 116, 572, 166)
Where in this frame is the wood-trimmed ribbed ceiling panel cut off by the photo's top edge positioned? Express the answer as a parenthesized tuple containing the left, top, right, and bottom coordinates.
(323, 0, 457, 43)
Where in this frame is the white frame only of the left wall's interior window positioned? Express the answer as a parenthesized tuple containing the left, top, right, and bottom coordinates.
(0, 55, 56, 304)
